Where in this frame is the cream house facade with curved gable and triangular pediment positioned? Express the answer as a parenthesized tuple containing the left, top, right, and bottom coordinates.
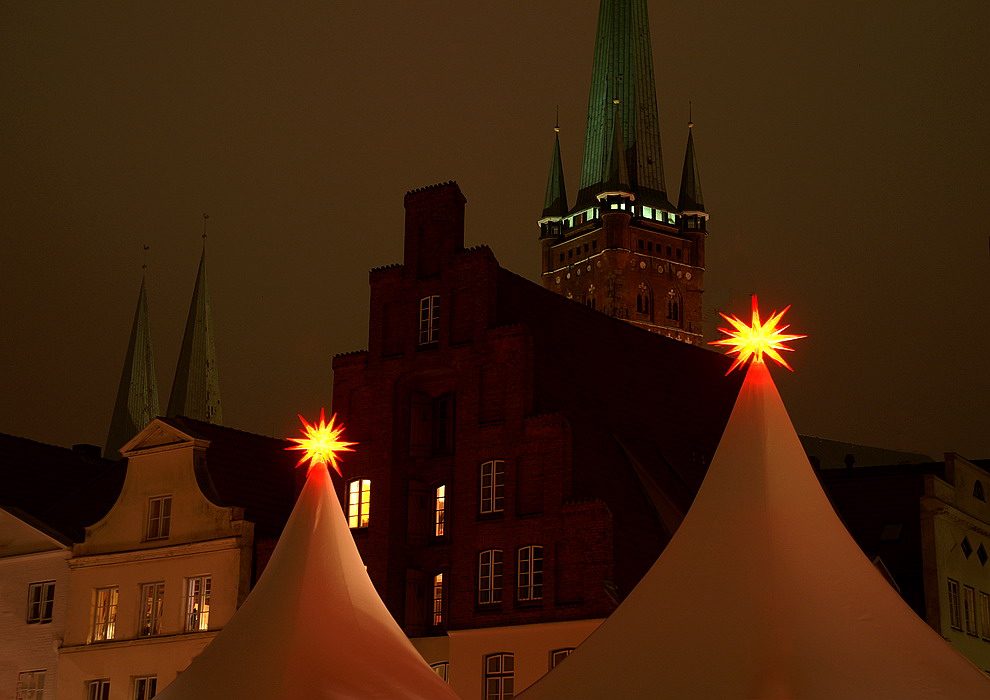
(58, 420, 262, 700)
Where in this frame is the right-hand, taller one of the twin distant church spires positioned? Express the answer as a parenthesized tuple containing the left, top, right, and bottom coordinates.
(168, 242, 223, 425)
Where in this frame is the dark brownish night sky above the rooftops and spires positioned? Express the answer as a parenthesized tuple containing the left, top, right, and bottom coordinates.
(0, 0, 990, 458)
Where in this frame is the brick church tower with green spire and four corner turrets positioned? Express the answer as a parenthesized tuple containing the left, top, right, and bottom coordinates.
(539, 0, 708, 344)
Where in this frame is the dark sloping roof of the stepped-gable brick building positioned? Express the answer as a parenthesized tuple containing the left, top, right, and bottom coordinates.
(497, 268, 743, 595)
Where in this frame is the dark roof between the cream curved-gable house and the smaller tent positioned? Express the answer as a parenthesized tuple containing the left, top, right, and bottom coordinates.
(162, 416, 298, 536)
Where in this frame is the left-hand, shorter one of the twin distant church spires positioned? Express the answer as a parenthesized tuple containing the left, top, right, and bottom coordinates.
(104, 277, 159, 459)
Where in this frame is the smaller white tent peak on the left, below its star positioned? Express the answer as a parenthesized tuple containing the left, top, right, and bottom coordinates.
(157, 465, 457, 700)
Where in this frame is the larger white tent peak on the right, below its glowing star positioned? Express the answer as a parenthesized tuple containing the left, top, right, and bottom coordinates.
(519, 363, 990, 700)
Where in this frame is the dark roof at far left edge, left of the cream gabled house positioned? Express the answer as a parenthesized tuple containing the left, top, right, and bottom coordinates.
(0, 434, 125, 542)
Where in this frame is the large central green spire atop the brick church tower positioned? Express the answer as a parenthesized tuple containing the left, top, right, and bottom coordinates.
(576, 0, 673, 210)
